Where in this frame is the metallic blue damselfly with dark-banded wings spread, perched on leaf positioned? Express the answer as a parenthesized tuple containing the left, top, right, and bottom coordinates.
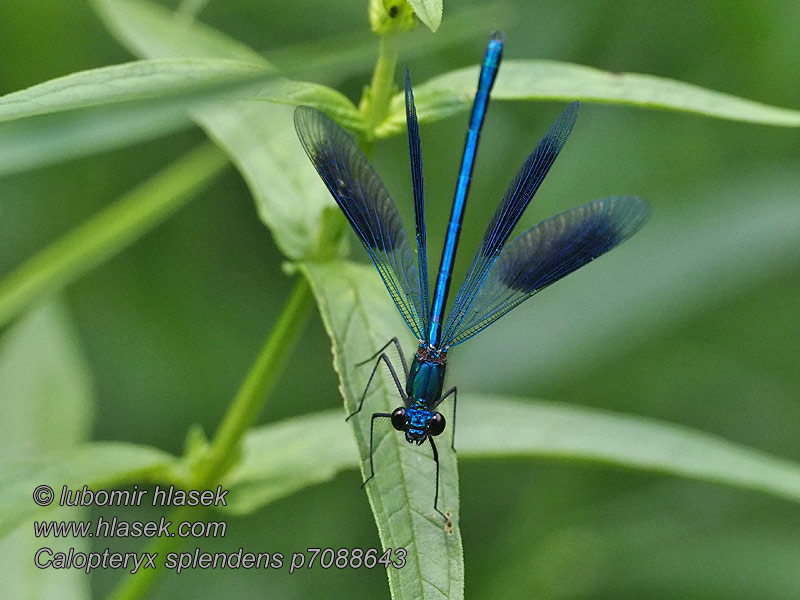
(294, 32, 650, 518)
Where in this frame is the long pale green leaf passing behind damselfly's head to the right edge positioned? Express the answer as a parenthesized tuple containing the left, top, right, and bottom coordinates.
(226, 394, 800, 517)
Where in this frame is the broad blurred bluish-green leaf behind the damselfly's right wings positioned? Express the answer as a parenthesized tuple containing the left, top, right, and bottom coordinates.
(484, 172, 800, 389)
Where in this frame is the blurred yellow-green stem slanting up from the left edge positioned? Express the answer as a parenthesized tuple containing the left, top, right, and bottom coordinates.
(0, 143, 229, 327)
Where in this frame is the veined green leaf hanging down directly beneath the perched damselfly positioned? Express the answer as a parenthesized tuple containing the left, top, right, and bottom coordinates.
(298, 261, 464, 599)
